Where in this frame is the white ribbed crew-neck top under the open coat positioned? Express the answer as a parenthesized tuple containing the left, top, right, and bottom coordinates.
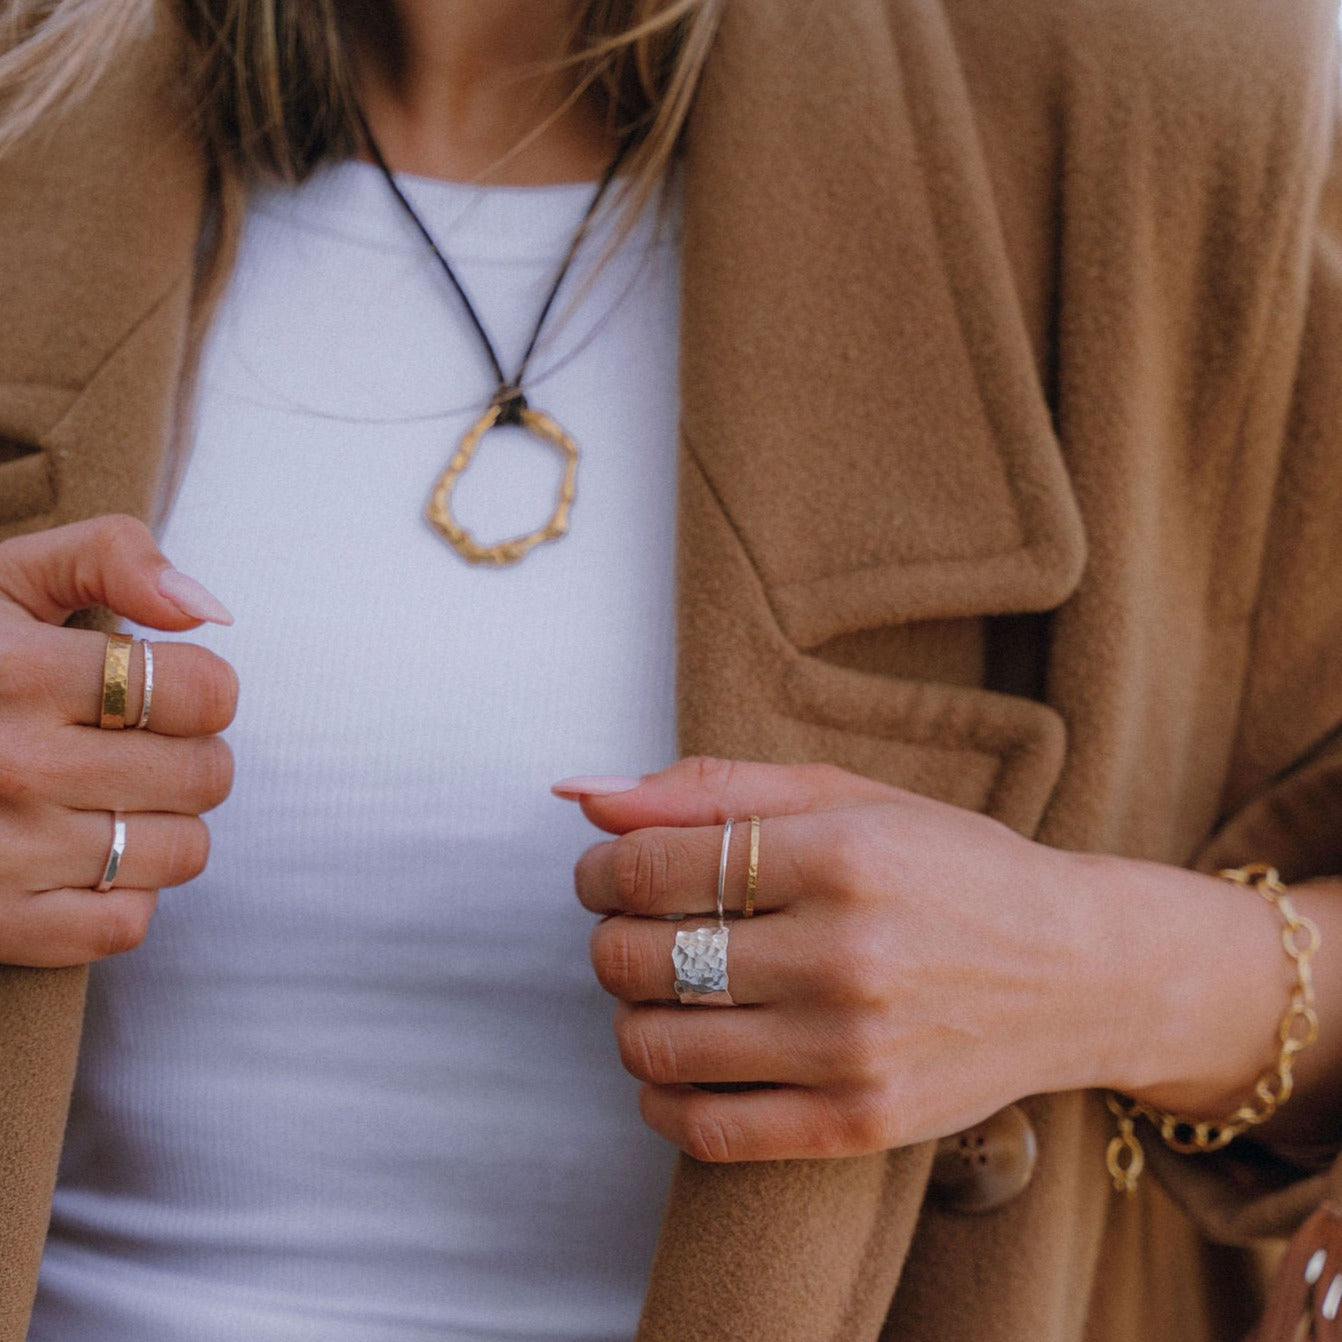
(30, 164, 678, 1342)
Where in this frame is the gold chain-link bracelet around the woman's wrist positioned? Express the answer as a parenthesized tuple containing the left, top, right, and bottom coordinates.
(1104, 863, 1319, 1193)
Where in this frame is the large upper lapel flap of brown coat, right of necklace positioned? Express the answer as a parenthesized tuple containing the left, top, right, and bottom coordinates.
(683, 0, 1084, 648)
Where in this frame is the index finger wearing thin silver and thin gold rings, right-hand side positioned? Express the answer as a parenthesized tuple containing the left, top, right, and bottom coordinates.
(573, 816, 805, 918)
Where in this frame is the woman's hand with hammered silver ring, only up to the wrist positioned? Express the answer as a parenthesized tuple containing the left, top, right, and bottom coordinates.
(556, 760, 1138, 1161)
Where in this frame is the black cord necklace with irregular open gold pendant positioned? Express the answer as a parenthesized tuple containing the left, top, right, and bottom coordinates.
(360, 113, 629, 565)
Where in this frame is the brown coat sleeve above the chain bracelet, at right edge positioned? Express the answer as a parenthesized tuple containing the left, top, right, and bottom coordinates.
(1143, 91, 1342, 1243)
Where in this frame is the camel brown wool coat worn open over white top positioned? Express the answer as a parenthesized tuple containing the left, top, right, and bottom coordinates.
(0, 0, 1342, 1342)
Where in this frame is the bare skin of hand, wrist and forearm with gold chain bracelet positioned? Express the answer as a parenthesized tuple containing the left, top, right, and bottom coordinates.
(556, 760, 1342, 1161)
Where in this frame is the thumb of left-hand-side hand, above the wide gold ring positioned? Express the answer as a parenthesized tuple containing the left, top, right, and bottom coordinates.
(0, 514, 234, 631)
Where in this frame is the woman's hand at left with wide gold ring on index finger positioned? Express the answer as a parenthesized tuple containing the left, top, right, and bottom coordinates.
(0, 517, 238, 966)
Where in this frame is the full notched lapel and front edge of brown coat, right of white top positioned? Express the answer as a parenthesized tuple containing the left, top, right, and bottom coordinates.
(639, 0, 1084, 1342)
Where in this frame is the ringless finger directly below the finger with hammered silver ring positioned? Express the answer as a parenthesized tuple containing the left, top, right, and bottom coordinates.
(615, 1002, 817, 1086)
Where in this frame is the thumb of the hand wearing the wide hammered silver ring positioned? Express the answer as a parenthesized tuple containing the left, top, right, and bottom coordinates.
(552, 756, 902, 833)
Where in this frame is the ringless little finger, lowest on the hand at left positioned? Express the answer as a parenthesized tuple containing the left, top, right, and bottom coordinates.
(0, 886, 158, 969)
